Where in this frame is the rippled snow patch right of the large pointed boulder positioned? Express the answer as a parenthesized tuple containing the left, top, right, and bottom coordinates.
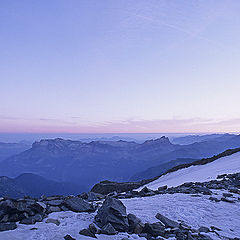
(123, 191, 240, 240)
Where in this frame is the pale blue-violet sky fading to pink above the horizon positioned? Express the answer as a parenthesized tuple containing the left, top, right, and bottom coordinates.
(0, 0, 240, 133)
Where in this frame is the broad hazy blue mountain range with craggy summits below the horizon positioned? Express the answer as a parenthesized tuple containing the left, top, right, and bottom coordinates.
(0, 135, 240, 187)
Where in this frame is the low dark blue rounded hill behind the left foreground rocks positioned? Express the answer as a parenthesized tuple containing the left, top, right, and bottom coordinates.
(0, 173, 87, 198)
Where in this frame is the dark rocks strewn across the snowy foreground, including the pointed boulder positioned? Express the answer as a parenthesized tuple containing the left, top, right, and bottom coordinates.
(0, 173, 240, 240)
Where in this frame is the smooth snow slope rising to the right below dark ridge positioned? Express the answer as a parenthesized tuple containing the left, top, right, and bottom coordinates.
(140, 152, 240, 190)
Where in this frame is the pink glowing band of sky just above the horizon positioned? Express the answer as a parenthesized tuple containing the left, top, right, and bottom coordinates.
(0, 119, 240, 133)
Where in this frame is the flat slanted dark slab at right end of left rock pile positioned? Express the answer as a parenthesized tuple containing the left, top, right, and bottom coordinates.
(65, 197, 94, 212)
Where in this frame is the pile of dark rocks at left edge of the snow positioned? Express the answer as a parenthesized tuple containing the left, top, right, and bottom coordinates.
(0, 196, 95, 231)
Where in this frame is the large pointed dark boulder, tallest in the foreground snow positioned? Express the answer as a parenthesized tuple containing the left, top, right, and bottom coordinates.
(95, 197, 129, 232)
